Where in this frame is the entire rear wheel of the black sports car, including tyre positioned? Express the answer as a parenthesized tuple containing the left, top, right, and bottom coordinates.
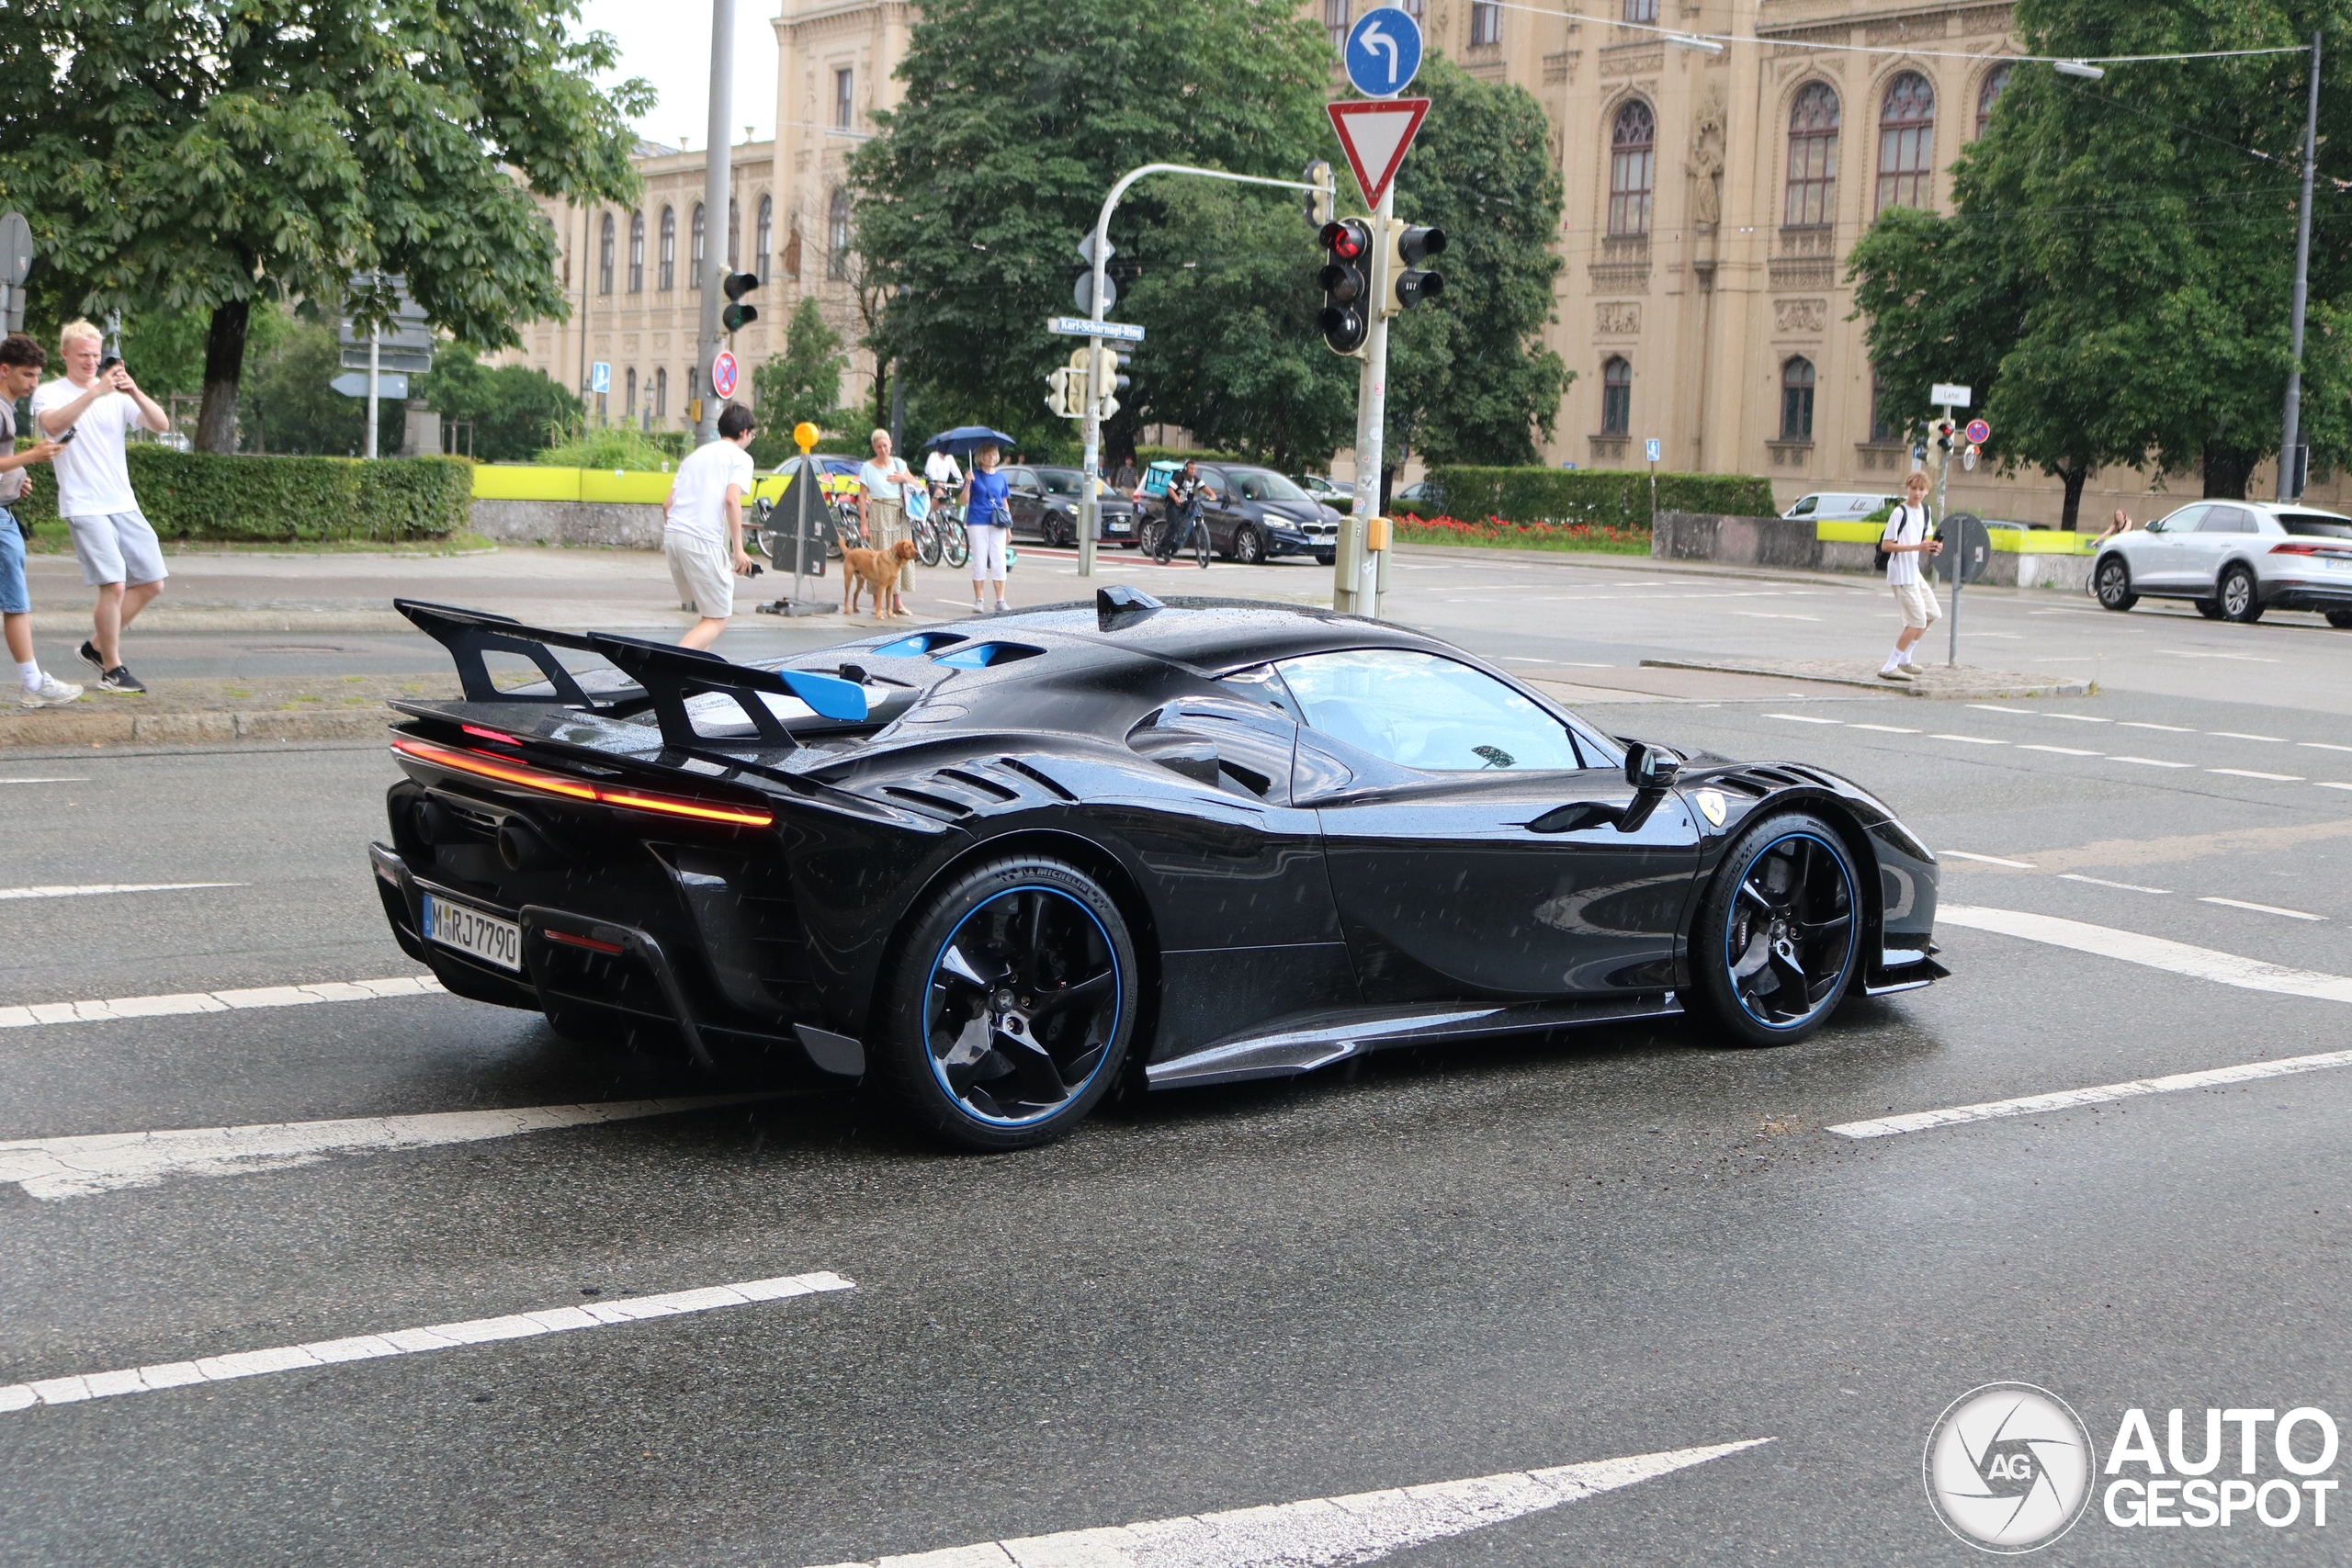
(879, 856, 1136, 1149)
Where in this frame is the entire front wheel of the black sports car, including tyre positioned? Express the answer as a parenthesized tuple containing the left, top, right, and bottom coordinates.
(1691, 811, 1863, 1046)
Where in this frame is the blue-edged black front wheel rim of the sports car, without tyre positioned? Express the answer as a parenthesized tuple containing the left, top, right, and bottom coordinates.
(1724, 828, 1860, 1030)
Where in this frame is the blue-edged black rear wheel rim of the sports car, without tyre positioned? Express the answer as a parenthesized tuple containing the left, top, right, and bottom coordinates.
(922, 882, 1126, 1128)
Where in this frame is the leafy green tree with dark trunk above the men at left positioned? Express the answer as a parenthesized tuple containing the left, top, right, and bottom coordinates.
(0, 0, 654, 451)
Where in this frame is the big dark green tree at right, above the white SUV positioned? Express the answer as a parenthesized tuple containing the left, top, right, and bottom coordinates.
(1851, 0, 2352, 502)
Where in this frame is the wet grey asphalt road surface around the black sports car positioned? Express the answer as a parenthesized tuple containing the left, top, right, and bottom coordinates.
(0, 545, 2352, 1568)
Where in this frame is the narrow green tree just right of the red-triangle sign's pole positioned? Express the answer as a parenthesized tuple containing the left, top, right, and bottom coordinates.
(1381, 54, 1571, 493)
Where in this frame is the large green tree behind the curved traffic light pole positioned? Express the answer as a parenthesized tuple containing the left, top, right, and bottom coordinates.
(852, 0, 1331, 437)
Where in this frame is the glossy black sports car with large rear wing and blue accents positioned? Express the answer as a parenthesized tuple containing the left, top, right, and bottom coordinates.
(371, 588, 1945, 1149)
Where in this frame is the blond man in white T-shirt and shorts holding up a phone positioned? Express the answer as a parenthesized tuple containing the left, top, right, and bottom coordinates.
(33, 322, 172, 696)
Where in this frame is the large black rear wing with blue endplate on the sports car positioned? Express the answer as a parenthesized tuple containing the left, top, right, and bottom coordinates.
(393, 600, 865, 750)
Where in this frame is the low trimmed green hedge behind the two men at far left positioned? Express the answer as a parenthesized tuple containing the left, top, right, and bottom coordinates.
(14, 442, 473, 541)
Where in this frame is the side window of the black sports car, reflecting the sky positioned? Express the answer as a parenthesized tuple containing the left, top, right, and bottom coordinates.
(1277, 649, 1583, 771)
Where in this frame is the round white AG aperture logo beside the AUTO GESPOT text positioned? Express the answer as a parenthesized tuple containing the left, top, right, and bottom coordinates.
(1924, 1382, 2098, 1556)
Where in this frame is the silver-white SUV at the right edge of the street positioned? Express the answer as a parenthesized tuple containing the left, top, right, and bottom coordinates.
(2091, 501, 2352, 627)
